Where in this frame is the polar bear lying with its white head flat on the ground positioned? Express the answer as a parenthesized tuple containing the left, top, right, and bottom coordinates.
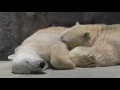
(8, 27, 78, 74)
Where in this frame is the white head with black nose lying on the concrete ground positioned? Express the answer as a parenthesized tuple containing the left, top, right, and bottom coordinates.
(8, 47, 47, 74)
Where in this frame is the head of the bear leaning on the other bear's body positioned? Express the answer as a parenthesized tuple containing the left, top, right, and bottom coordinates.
(60, 22, 90, 50)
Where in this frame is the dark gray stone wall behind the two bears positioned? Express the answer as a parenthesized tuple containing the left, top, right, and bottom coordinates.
(0, 12, 120, 60)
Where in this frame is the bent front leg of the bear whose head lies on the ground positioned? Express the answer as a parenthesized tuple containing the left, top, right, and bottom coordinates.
(50, 43, 75, 69)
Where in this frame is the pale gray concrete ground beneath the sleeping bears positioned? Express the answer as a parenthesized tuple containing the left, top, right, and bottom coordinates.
(0, 61, 120, 78)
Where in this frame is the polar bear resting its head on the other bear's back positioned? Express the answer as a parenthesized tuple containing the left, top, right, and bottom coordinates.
(61, 23, 120, 67)
